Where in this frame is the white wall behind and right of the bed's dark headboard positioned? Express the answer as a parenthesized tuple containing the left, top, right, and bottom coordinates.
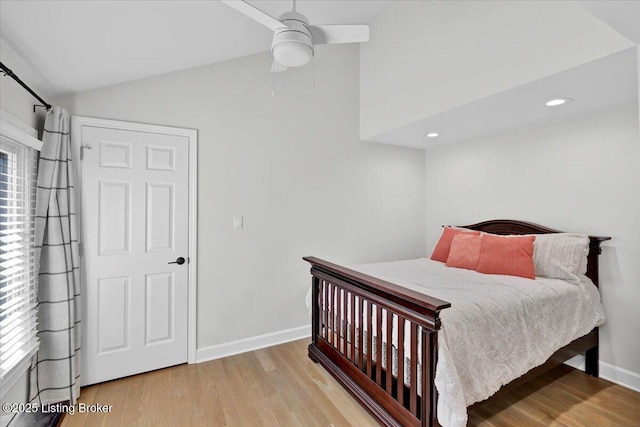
(425, 105, 640, 378)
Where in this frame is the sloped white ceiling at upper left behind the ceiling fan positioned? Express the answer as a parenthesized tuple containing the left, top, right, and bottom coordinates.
(0, 0, 389, 97)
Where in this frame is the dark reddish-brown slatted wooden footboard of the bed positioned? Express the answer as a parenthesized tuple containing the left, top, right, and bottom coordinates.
(304, 257, 451, 426)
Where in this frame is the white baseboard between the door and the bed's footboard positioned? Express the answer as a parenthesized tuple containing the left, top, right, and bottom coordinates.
(196, 325, 311, 363)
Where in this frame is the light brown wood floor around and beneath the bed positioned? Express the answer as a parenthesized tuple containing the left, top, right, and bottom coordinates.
(62, 339, 640, 427)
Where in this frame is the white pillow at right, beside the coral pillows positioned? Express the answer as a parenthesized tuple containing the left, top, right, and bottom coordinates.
(533, 233, 589, 283)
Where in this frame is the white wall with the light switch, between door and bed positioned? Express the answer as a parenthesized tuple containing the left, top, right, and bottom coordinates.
(55, 45, 425, 349)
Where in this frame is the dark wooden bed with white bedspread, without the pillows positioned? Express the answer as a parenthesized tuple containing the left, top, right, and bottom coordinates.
(304, 220, 609, 426)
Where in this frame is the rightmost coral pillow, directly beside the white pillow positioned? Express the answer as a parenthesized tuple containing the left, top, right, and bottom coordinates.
(476, 234, 536, 279)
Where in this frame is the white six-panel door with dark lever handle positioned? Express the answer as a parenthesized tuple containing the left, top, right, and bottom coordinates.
(76, 118, 195, 385)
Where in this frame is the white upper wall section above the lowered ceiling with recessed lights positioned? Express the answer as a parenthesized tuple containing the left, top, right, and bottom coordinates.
(360, 1, 633, 139)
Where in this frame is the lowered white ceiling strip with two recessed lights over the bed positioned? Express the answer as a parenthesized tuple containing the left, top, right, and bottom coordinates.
(372, 47, 638, 148)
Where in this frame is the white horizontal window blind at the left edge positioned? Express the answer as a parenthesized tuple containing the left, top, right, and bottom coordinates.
(0, 132, 38, 389)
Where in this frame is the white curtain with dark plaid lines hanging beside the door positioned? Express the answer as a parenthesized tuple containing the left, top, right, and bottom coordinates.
(29, 107, 81, 404)
